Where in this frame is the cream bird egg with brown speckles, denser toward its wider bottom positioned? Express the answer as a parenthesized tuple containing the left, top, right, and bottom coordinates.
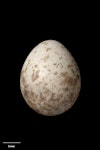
(20, 40, 81, 116)
